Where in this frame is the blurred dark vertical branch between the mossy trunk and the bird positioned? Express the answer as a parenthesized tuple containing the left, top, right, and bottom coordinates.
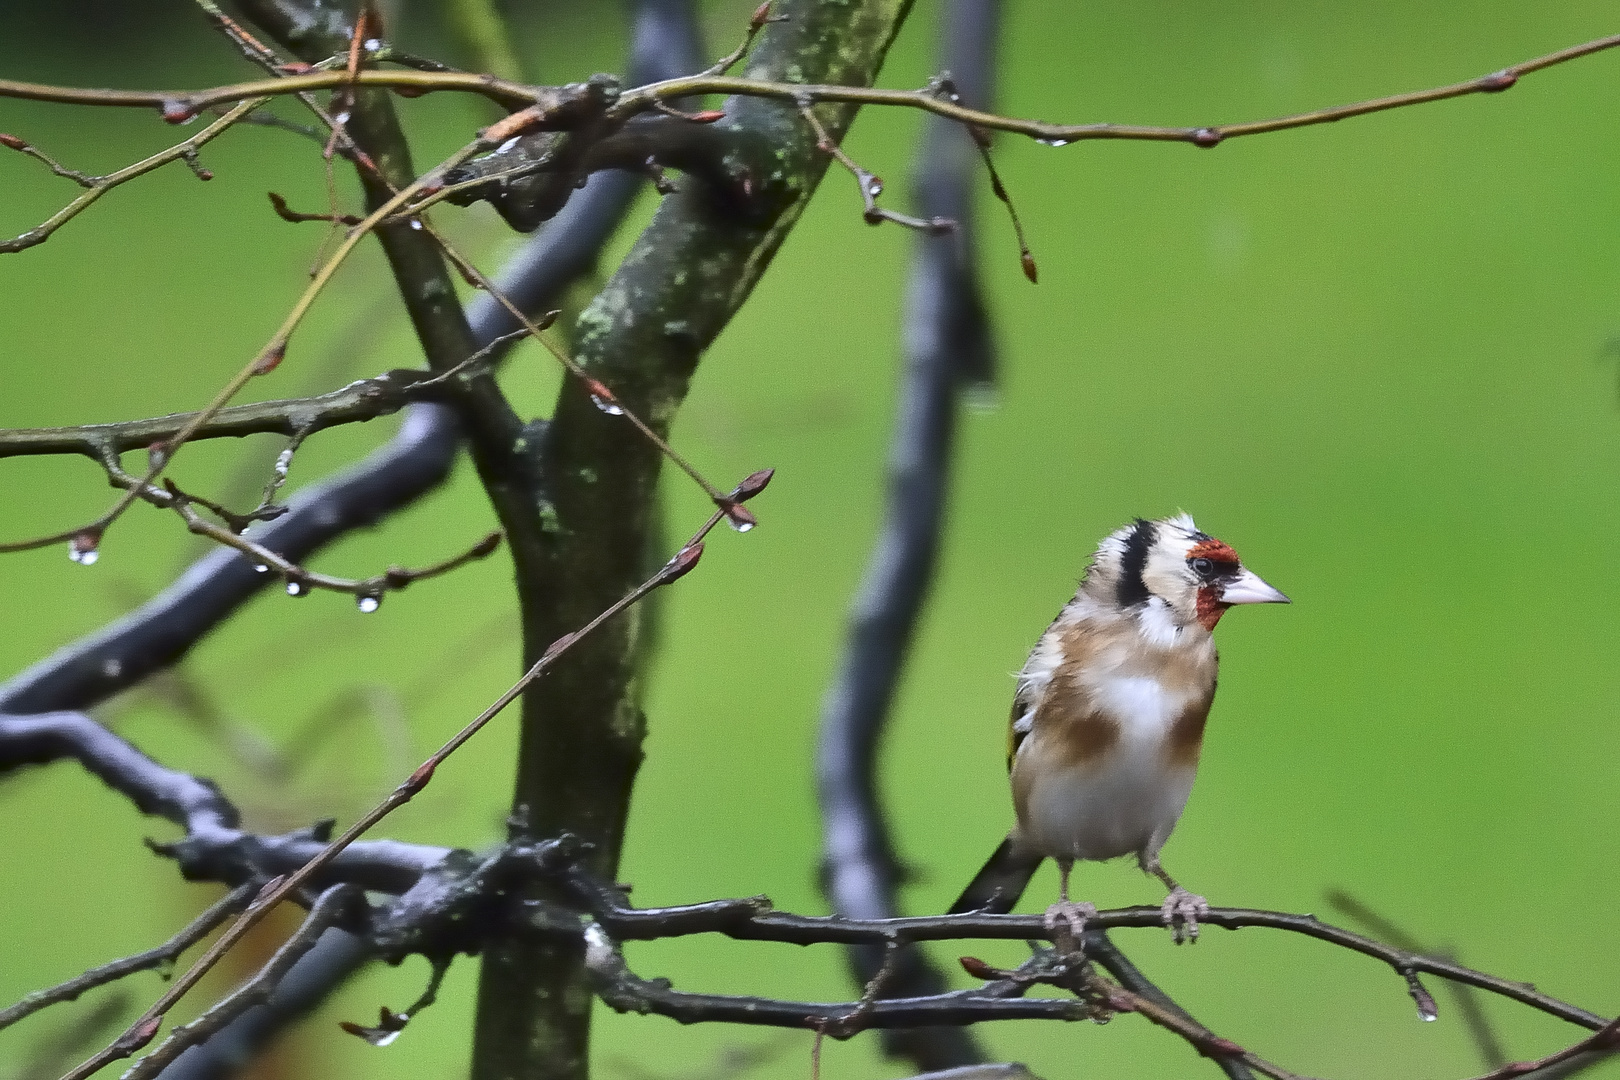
(816, 0, 1000, 1070)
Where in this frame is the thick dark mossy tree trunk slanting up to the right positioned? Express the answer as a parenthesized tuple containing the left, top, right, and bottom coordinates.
(473, 0, 910, 1080)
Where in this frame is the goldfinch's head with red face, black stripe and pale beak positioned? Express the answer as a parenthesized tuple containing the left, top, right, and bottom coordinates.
(1082, 513, 1288, 630)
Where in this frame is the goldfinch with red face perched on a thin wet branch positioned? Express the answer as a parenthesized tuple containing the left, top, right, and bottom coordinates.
(951, 513, 1290, 944)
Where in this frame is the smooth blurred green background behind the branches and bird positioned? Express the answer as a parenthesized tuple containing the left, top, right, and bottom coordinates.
(0, 0, 1620, 1080)
